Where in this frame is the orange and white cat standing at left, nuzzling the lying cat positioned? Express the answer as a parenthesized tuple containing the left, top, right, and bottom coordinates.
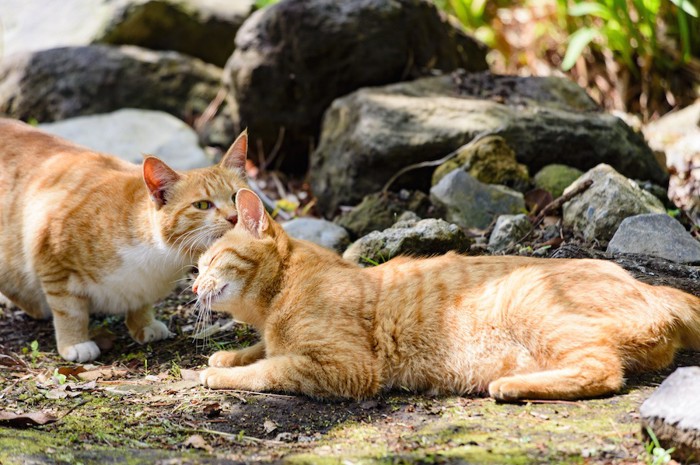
(0, 119, 247, 362)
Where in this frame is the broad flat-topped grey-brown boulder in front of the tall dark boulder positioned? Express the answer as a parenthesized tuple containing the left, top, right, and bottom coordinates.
(310, 73, 666, 216)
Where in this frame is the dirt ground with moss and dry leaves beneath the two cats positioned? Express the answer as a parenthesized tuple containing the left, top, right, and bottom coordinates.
(0, 278, 700, 465)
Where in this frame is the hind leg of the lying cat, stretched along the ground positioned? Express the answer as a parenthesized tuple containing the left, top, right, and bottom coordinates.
(489, 354, 624, 401)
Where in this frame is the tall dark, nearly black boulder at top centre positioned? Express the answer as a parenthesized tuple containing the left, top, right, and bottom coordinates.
(226, 0, 487, 171)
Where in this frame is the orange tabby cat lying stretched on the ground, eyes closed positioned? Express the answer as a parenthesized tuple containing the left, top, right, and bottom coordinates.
(193, 189, 700, 401)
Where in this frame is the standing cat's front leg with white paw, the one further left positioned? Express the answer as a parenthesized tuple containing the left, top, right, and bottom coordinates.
(47, 291, 100, 363)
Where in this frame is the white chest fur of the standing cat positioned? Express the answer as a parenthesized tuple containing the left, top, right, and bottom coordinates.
(77, 244, 191, 313)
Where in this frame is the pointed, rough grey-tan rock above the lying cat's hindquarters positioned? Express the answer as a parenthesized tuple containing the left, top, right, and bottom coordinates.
(563, 164, 666, 243)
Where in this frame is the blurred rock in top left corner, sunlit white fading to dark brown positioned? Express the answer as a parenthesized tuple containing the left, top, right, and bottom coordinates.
(2, 0, 254, 66)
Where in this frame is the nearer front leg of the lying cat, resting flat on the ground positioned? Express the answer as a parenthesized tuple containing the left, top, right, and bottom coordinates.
(199, 355, 329, 397)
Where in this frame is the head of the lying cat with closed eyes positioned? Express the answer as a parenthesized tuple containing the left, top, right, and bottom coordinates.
(192, 189, 290, 325)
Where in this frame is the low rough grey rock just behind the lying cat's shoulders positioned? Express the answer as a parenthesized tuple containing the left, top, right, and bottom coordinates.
(343, 218, 472, 265)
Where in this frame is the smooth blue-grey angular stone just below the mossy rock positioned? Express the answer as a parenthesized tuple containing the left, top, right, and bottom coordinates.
(430, 170, 525, 229)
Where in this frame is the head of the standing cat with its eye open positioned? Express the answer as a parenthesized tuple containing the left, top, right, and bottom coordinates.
(143, 131, 248, 256)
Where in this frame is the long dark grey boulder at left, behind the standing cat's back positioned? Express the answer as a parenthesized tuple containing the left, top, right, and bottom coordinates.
(0, 45, 221, 122)
